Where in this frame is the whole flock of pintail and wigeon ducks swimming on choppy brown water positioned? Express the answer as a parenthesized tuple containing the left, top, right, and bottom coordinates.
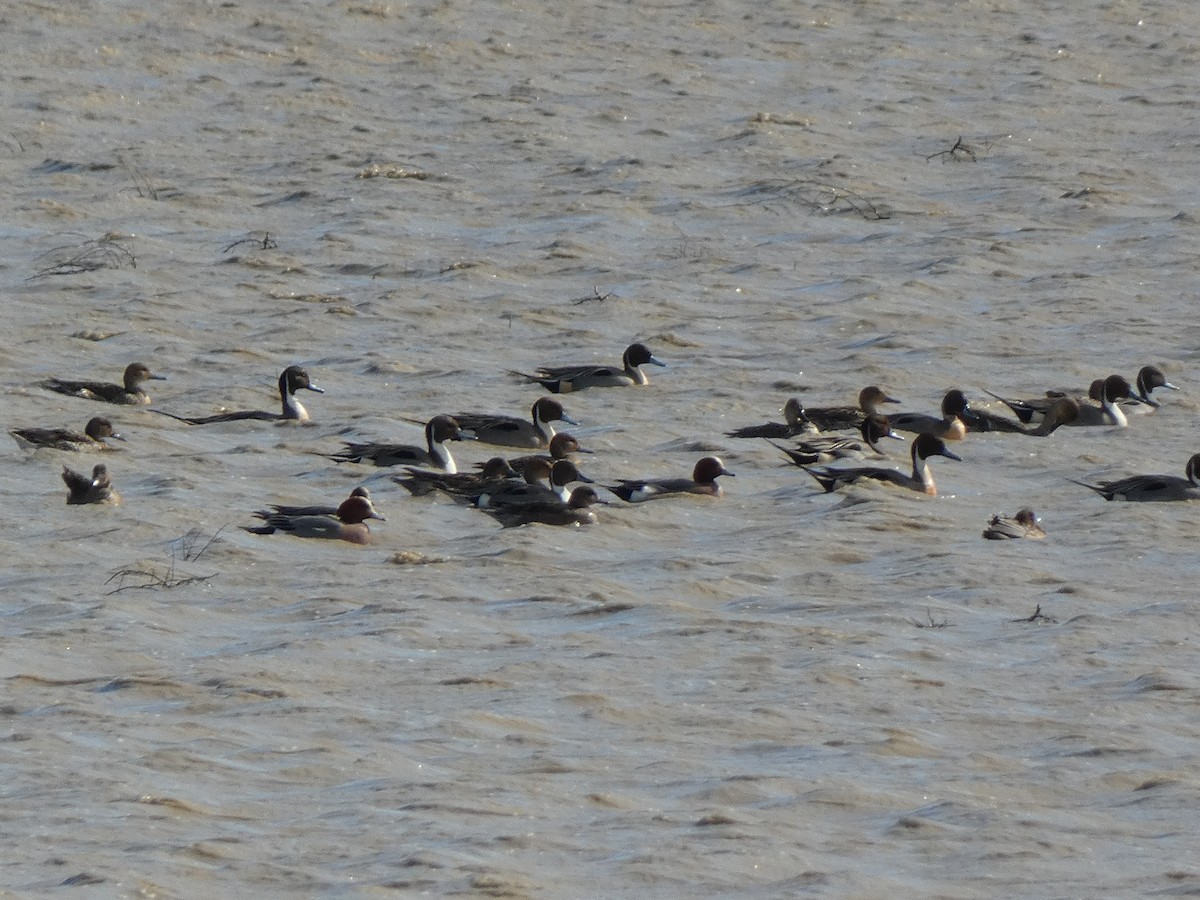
(12, 343, 1200, 544)
